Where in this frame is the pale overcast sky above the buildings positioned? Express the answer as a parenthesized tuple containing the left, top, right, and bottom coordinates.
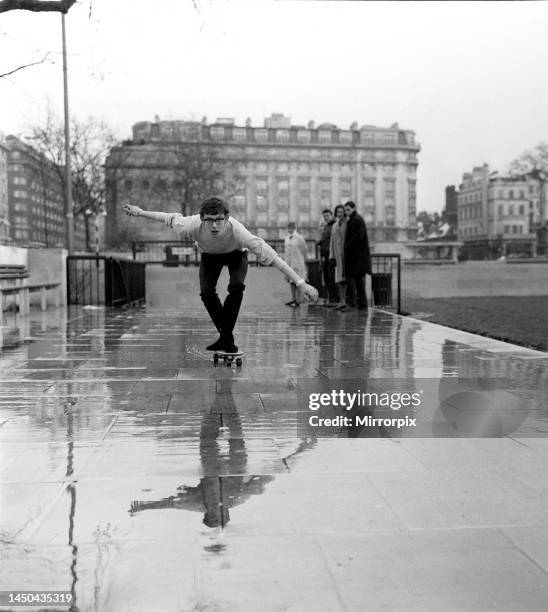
(0, 0, 548, 211)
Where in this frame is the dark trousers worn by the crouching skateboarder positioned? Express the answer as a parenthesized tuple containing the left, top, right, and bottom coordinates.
(200, 251, 247, 341)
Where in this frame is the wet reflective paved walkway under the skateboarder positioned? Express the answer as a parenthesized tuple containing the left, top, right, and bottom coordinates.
(0, 307, 548, 612)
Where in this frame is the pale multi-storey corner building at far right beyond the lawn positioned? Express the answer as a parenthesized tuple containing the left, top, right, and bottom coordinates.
(458, 164, 540, 259)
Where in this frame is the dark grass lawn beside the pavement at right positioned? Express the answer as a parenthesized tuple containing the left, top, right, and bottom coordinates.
(402, 295, 548, 351)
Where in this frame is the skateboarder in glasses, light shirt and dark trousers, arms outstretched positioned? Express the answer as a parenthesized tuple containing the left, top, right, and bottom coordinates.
(124, 198, 318, 353)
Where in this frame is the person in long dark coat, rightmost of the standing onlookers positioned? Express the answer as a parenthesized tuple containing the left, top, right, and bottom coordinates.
(344, 201, 371, 310)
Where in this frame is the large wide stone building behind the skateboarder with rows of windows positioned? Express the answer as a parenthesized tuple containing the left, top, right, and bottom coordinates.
(106, 114, 420, 252)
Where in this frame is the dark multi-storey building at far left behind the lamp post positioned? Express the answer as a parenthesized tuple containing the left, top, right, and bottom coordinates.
(6, 136, 85, 251)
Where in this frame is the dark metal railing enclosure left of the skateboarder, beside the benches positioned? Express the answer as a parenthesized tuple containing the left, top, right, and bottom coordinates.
(67, 255, 145, 306)
